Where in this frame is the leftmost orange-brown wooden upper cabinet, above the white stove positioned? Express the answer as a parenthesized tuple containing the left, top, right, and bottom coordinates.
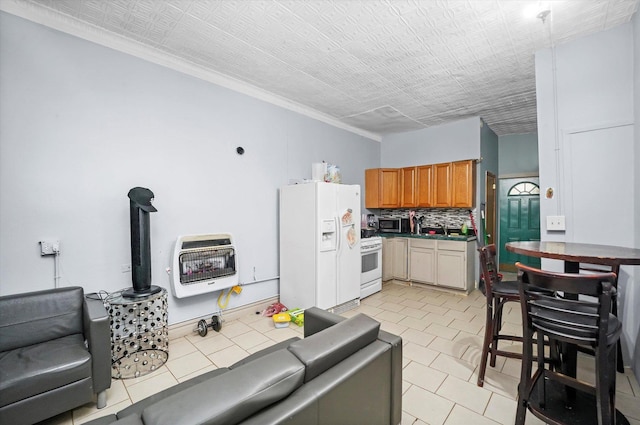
(364, 168, 400, 208)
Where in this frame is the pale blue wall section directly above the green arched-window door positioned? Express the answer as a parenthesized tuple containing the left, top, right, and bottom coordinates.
(498, 133, 538, 176)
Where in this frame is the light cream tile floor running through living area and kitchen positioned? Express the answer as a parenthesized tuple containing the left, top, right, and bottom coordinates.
(42, 283, 640, 425)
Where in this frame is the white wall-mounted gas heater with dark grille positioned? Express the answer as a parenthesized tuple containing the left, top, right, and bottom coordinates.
(172, 233, 238, 298)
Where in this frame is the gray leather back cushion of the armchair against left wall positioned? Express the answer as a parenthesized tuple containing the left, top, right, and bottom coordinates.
(0, 287, 84, 351)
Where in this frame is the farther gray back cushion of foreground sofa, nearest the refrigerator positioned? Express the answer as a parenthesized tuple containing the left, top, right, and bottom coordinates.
(288, 313, 380, 382)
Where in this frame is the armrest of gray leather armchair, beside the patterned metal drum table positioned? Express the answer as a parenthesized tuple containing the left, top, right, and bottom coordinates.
(83, 297, 111, 394)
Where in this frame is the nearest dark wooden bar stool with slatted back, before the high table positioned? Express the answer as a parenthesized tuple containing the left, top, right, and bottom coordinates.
(516, 263, 622, 425)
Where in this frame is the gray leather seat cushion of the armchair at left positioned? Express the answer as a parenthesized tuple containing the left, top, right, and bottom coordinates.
(0, 334, 91, 406)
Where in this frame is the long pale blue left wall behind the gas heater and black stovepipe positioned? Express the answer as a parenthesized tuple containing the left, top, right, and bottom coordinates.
(0, 13, 380, 323)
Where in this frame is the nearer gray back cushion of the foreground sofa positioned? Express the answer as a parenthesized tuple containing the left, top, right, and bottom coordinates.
(142, 349, 304, 425)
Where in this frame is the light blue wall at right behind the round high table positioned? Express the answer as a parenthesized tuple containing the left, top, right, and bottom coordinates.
(536, 21, 640, 368)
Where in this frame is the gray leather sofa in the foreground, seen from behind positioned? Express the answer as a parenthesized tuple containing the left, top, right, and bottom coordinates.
(86, 307, 402, 425)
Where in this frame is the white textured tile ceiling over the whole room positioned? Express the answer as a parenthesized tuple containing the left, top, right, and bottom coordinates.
(20, 0, 640, 135)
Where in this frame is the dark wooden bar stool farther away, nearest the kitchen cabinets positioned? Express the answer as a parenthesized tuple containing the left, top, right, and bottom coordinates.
(478, 244, 522, 387)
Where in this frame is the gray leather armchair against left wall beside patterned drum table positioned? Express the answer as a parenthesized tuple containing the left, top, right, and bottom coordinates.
(0, 287, 111, 425)
